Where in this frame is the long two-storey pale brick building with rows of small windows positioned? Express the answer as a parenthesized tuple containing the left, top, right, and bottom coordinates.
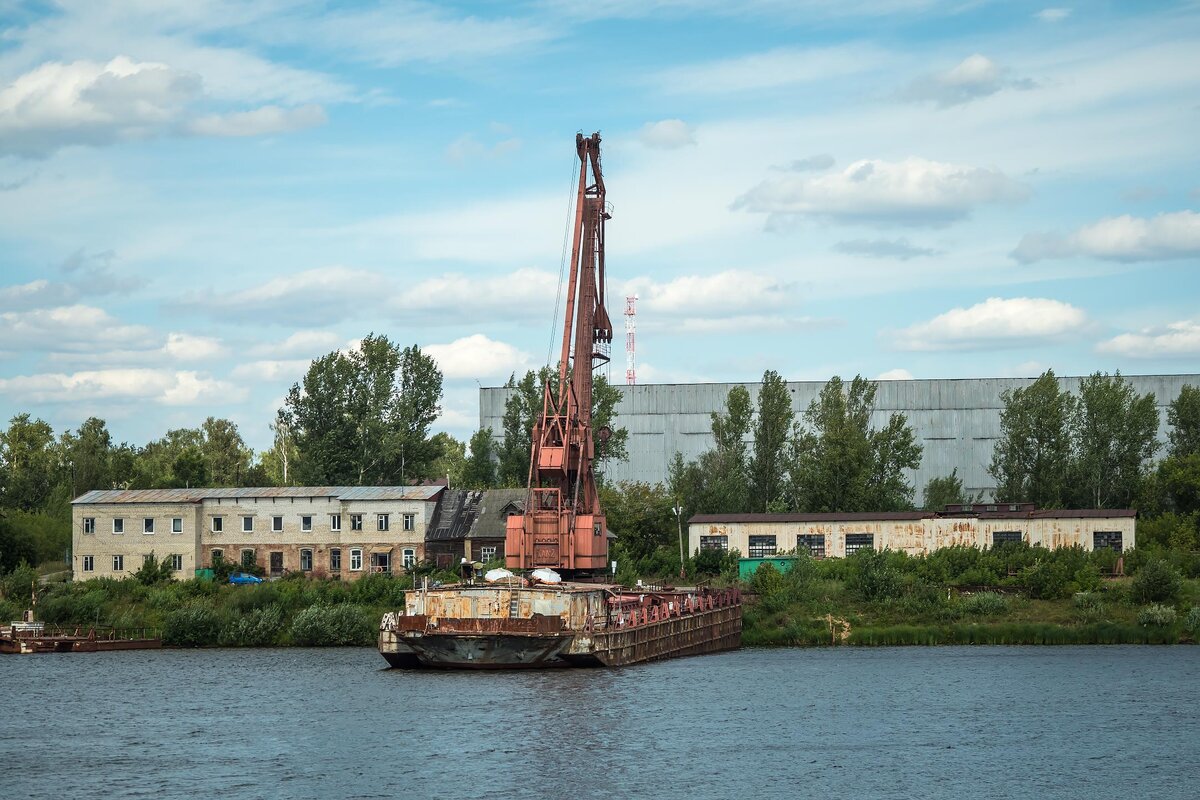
(71, 486, 445, 581)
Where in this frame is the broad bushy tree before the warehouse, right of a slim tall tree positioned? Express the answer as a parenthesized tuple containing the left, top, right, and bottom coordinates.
(790, 375, 922, 512)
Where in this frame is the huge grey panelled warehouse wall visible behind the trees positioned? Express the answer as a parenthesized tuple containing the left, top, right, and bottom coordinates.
(479, 374, 1200, 503)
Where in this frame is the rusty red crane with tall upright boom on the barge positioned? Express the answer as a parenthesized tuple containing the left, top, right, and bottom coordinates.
(504, 133, 612, 575)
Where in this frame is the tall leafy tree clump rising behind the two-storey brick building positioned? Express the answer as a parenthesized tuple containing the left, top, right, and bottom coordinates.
(282, 333, 442, 486)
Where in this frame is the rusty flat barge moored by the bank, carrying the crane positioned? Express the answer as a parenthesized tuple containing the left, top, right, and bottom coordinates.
(379, 583, 742, 669)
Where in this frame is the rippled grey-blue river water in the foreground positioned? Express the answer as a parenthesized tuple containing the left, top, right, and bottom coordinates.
(0, 646, 1200, 800)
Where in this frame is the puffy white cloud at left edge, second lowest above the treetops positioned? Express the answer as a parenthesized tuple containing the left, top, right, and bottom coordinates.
(0, 305, 154, 351)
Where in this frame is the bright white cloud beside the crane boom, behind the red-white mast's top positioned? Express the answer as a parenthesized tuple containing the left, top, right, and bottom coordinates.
(624, 270, 794, 317)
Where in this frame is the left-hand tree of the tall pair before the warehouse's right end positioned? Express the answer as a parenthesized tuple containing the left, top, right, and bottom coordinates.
(989, 369, 1075, 509)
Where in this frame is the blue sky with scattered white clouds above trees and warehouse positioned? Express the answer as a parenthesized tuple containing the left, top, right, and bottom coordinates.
(0, 0, 1200, 449)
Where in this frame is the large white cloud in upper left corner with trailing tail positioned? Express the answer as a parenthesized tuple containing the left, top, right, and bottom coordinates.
(0, 55, 324, 158)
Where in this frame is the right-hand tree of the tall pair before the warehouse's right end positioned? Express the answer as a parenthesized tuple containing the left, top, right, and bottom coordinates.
(1064, 372, 1159, 509)
